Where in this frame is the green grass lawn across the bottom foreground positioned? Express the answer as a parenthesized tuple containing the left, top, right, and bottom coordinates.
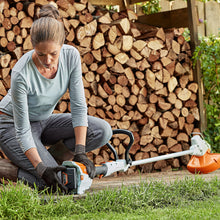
(0, 176, 220, 220)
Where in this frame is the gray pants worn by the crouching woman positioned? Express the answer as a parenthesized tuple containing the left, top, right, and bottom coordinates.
(0, 113, 112, 188)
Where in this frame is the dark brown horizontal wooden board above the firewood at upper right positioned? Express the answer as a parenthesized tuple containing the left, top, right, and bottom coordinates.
(138, 8, 189, 28)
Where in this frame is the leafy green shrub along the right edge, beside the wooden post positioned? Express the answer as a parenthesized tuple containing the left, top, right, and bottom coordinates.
(193, 36, 220, 152)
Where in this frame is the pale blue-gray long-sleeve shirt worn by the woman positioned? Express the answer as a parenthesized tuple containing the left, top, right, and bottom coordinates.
(0, 45, 88, 152)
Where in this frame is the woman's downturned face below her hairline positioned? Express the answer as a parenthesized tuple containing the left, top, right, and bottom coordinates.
(34, 41, 62, 69)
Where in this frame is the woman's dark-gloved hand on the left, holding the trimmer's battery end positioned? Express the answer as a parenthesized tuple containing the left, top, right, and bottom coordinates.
(36, 162, 68, 193)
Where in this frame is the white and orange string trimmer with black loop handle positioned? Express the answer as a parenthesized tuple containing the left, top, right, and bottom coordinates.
(62, 129, 220, 194)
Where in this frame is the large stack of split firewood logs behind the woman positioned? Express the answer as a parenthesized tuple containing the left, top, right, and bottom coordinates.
(0, 0, 200, 173)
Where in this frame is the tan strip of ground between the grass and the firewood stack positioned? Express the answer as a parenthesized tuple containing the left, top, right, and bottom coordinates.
(89, 169, 220, 192)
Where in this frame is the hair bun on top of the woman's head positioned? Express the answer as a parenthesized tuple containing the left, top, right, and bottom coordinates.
(38, 4, 61, 20)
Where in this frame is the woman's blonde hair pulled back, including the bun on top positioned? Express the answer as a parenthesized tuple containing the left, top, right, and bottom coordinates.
(30, 4, 65, 47)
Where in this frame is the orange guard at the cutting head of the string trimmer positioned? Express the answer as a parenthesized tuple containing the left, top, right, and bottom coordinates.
(187, 150, 220, 174)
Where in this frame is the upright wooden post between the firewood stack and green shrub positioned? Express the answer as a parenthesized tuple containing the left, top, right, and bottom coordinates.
(187, 0, 206, 132)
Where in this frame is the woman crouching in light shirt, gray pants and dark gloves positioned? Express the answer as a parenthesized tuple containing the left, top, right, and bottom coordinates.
(0, 5, 112, 190)
